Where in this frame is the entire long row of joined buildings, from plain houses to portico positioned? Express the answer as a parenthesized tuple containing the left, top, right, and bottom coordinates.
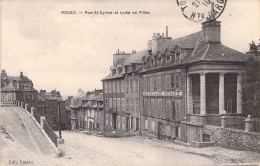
(102, 21, 253, 143)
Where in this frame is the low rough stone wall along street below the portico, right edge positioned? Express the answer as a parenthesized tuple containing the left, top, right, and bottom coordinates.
(204, 125, 260, 152)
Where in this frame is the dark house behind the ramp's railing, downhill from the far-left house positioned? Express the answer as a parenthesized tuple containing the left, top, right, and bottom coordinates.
(36, 90, 70, 130)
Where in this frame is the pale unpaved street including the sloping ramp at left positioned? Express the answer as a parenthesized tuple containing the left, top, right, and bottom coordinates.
(0, 107, 259, 166)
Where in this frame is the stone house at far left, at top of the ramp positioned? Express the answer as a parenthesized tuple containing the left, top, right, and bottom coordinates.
(1, 70, 37, 106)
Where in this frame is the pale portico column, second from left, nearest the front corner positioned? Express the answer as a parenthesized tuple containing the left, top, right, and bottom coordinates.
(200, 73, 206, 115)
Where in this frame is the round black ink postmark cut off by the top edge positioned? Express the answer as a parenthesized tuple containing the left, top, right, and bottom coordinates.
(177, 0, 227, 23)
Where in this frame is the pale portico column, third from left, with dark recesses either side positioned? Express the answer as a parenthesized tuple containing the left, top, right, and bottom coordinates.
(218, 73, 225, 114)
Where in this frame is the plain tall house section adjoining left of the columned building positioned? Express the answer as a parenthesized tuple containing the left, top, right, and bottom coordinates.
(102, 50, 148, 132)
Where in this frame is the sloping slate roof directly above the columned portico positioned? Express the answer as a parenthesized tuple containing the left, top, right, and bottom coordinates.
(186, 43, 248, 63)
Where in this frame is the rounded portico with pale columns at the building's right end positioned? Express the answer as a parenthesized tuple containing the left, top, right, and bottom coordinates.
(187, 66, 244, 115)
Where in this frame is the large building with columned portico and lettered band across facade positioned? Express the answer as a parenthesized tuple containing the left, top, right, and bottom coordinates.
(141, 21, 248, 143)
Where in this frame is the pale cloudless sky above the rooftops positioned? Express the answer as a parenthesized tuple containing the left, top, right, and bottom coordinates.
(0, 0, 260, 96)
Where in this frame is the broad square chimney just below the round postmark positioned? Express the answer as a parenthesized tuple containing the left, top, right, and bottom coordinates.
(202, 20, 221, 43)
